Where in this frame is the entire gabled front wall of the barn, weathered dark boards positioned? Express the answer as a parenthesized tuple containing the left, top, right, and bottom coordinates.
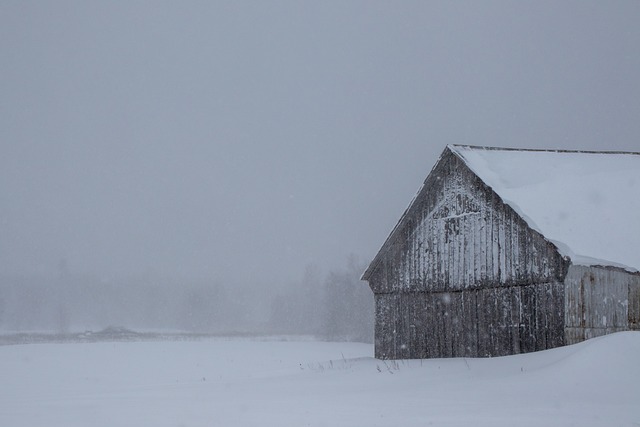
(368, 150, 566, 358)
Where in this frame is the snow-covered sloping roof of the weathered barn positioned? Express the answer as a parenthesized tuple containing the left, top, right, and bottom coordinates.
(449, 145, 640, 271)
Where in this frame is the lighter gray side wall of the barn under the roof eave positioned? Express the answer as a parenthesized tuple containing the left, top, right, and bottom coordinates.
(565, 265, 640, 344)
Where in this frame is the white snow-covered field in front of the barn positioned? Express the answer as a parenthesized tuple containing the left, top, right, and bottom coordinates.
(0, 332, 640, 427)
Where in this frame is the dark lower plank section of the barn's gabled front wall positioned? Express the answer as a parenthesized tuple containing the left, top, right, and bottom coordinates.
(375, 282, 564, 359)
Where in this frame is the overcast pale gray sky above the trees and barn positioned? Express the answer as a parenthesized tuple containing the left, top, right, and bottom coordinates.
(0, 0, 640, 283)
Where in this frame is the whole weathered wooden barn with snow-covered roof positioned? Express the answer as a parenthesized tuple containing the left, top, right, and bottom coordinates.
(363, 145, 640, 359)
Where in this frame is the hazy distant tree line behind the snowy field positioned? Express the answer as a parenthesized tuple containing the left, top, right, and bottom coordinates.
(0, 256, 373, 342)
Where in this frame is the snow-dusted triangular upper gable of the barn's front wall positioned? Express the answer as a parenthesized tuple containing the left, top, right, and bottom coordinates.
(369, 151, 564, 298)
